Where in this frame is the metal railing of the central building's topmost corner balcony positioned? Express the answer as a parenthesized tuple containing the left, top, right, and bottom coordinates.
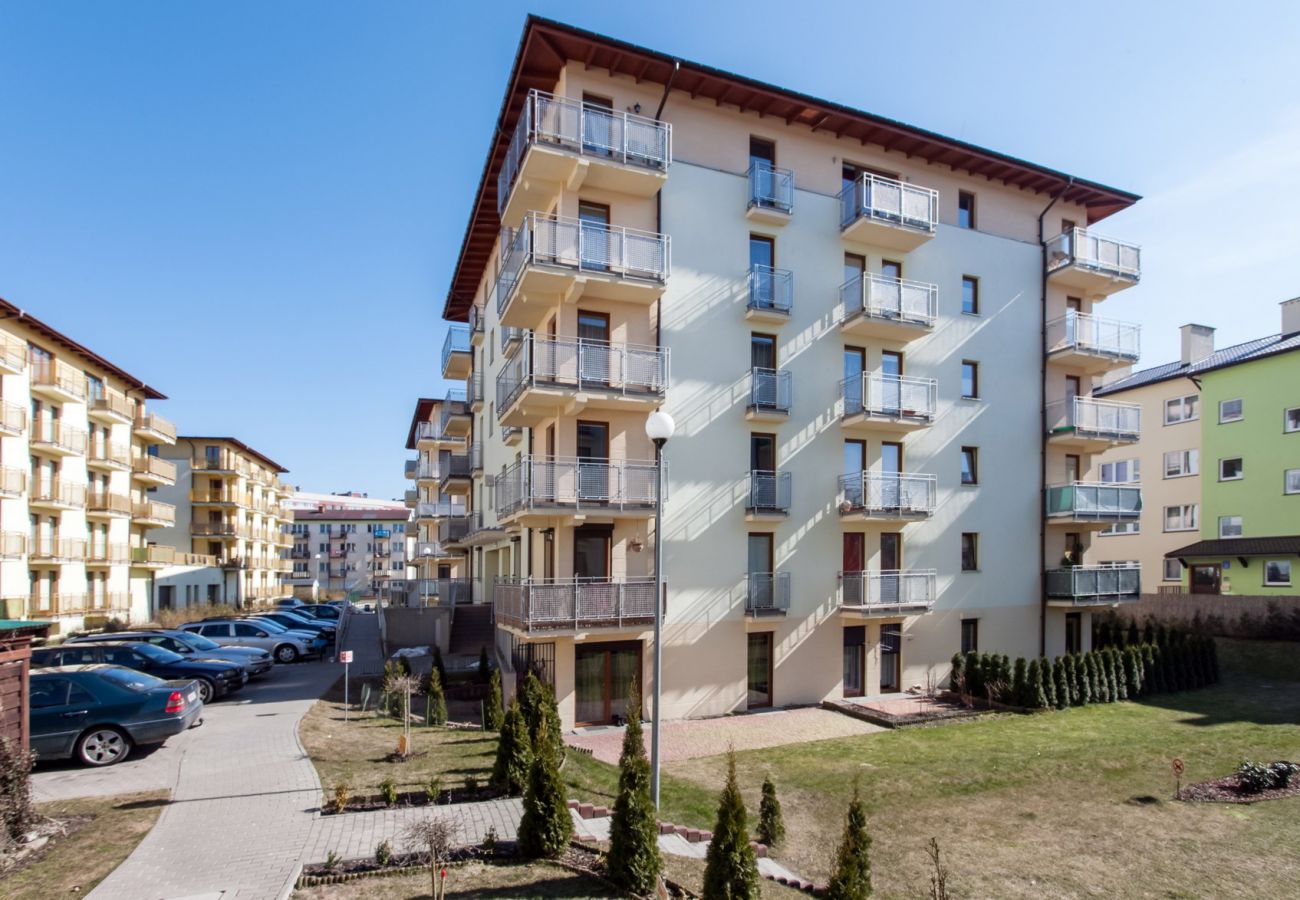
(497, 91, 672, 215)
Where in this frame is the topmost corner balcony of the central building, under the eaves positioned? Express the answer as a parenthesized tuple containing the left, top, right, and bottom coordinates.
(497, 91, 672, 224)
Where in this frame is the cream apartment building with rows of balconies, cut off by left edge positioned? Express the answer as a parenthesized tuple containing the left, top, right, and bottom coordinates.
(0, 300, 176, 633)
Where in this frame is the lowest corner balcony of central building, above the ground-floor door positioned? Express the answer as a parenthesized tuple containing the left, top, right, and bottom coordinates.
(493, 577, 655, 633)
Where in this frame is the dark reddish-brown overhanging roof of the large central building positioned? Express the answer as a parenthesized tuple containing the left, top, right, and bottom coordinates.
(443, 16, 1140, 320)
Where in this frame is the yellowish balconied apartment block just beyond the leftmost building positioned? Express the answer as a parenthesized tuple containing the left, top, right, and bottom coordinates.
(156, 436, 293, 606)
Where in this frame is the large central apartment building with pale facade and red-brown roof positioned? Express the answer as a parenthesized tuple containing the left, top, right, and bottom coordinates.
(431, 18, 1140, 727)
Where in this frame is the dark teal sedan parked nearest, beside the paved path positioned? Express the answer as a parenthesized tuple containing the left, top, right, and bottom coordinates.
(29, 666, 203, 766)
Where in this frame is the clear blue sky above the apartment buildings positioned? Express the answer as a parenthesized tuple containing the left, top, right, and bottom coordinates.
(0, 0, 1300, 497)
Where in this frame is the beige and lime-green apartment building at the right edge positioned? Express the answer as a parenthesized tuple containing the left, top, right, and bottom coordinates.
(1097, 298, 1300, 596)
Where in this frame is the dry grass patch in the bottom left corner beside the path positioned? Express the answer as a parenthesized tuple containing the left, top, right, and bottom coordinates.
(0, 791, 168, 900)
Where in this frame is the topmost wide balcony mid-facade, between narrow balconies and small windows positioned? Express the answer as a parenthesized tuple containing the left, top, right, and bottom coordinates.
(840, 172, 939, 251)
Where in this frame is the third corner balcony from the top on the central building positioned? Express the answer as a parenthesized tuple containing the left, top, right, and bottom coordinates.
(497, 334, 668, 427)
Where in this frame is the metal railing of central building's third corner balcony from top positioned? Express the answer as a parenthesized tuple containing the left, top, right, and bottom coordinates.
(497, 333, 668, 415)
